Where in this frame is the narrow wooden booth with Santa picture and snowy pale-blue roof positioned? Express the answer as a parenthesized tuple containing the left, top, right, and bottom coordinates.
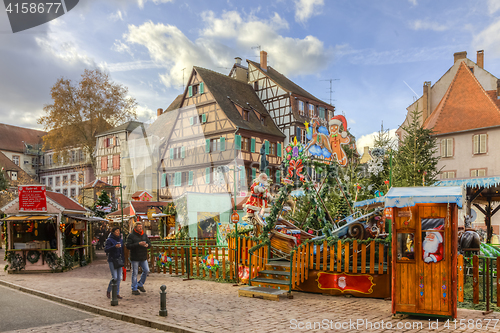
(385, 186, 463, 318)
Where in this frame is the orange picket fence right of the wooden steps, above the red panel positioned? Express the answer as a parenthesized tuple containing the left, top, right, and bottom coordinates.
(291, 240, 390, 287)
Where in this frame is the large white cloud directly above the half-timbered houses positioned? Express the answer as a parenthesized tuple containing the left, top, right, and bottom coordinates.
(118, 11, 333, 87)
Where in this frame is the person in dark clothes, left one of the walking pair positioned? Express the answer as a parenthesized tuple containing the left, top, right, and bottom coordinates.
(104, 227, 125, 299)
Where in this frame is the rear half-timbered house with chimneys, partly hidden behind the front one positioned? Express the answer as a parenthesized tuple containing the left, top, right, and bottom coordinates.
(229, 51, 335, 145)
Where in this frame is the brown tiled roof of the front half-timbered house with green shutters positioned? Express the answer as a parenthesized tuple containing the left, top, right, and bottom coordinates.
(194, 67, 285, 138)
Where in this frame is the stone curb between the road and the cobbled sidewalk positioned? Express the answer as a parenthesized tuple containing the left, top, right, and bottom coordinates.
(0, 280, 203, 333)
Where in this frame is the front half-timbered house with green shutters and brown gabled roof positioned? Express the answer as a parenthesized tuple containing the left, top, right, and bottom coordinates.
(159, 67, 285, 199)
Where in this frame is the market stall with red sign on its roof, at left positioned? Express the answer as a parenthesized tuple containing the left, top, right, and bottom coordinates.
(1, 186, 93, 273)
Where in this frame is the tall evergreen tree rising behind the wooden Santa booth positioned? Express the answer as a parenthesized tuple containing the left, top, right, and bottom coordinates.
(393, 108, 439, 187)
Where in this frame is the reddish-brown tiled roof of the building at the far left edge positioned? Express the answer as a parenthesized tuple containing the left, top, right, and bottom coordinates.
(0, 124, 47, 153)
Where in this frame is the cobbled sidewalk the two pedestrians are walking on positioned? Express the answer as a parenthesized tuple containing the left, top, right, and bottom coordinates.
(0, 246, 500, 332)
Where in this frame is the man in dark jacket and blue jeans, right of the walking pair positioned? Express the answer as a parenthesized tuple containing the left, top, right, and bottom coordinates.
(126, 222, 151, 295)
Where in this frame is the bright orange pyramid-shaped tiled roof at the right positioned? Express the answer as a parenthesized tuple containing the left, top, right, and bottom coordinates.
(424, 63, 500, 134)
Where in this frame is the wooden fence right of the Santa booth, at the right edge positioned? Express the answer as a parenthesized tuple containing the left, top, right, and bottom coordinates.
(457, 255, 500, 311)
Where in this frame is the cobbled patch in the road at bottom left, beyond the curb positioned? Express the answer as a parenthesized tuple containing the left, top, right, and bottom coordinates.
(5, 316, 163, 333)
